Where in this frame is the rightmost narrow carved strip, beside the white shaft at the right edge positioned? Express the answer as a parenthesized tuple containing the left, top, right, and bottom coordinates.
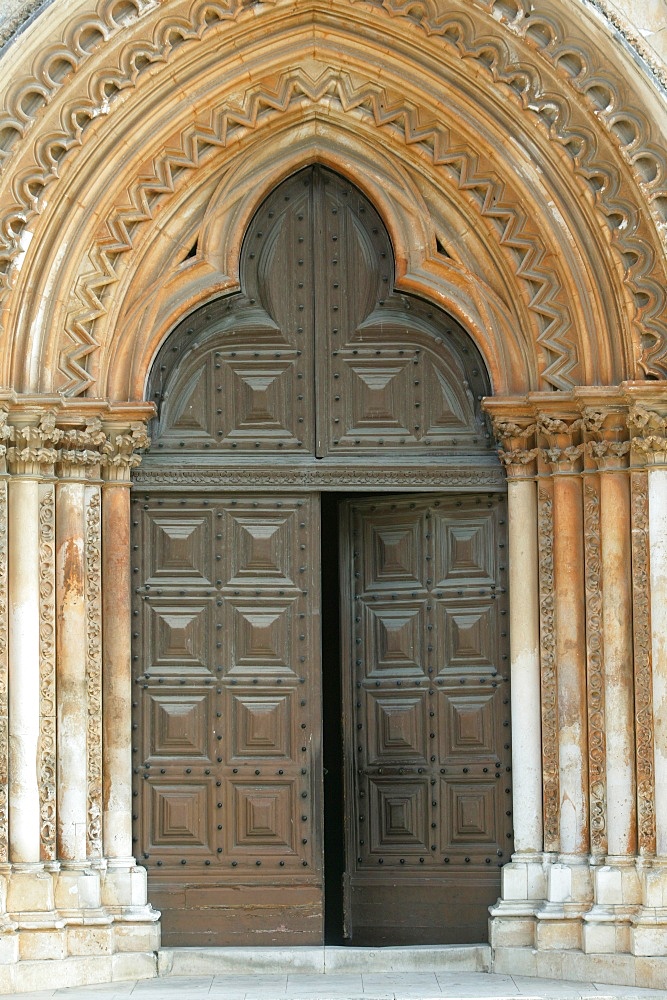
(631, 471, 656, 855)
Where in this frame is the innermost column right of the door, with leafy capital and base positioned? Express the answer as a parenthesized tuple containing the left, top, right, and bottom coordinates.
(491, 418, 545, 946)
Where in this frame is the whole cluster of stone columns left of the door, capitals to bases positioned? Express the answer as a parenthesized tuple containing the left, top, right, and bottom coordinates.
(0, 392, 159, 989)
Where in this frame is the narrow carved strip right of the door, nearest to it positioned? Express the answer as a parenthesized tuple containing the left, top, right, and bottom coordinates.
(537, 486, 560, 852)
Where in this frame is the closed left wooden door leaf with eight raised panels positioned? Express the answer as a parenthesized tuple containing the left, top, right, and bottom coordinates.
(132, 493, 323, 944)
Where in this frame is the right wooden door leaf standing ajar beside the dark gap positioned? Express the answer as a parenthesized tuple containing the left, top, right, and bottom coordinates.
(342, 496, 512, 945)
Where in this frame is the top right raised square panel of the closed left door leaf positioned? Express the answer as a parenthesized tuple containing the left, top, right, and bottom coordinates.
(228, 511, 294, 586)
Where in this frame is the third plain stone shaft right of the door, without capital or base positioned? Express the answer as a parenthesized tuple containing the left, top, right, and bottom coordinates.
(600, 471, 637, 857)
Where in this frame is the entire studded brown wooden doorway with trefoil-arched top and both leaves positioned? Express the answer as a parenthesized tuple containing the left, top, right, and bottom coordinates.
(133, 165, 511, 945)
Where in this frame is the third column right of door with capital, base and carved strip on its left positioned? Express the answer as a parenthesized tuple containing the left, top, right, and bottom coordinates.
(582, 400, 640, 953)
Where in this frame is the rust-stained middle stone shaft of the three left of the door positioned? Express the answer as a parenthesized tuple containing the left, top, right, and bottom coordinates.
(56, 480, 88, 861)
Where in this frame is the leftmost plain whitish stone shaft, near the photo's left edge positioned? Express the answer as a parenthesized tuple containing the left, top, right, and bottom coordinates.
(8, 476, 40, 863)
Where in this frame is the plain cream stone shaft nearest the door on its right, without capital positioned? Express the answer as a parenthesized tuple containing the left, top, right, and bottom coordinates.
(507, 478, 543, 853)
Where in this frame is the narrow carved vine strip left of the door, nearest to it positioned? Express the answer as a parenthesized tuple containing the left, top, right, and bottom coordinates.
(85, 487, 102, 858)
